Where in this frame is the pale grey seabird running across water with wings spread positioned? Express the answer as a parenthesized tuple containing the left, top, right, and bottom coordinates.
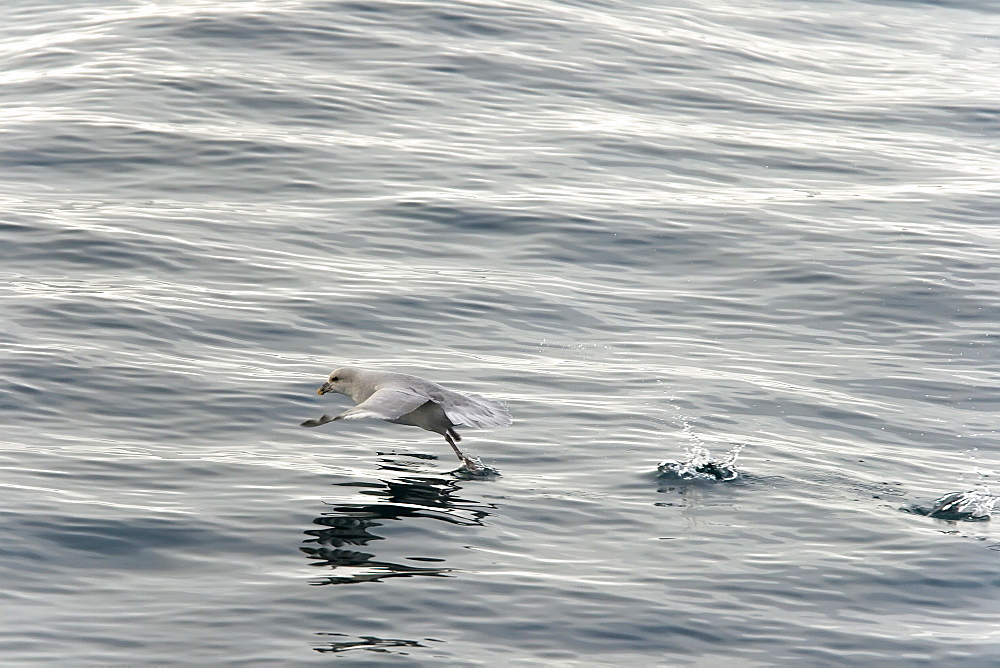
(302, 367, 513, 470)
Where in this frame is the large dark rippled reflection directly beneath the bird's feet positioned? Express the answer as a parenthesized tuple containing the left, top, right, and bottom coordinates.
(300, 464, 492, 585)
